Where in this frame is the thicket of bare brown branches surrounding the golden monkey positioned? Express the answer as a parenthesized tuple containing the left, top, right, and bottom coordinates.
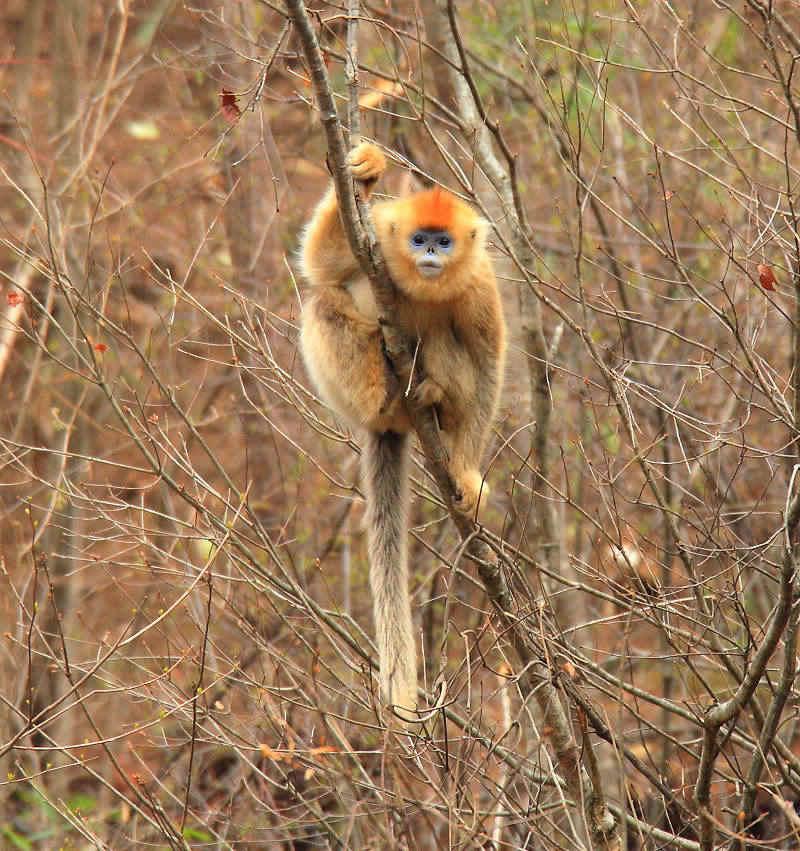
(0, 0, 800, 851)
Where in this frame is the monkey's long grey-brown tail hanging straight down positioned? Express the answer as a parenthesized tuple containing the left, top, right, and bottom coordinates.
(362, 431, 417, 717)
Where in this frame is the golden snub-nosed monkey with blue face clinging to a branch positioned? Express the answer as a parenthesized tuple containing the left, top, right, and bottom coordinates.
(301, 143, 505, 724)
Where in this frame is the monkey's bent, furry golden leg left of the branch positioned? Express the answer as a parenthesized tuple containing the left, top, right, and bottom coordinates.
(301, 287, 411, 432)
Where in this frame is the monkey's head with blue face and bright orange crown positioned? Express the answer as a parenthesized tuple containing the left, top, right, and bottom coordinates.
(376, 186, 486, 301)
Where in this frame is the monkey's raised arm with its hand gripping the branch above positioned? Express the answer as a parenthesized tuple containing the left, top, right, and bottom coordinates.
(300, 142, 386, 286)
